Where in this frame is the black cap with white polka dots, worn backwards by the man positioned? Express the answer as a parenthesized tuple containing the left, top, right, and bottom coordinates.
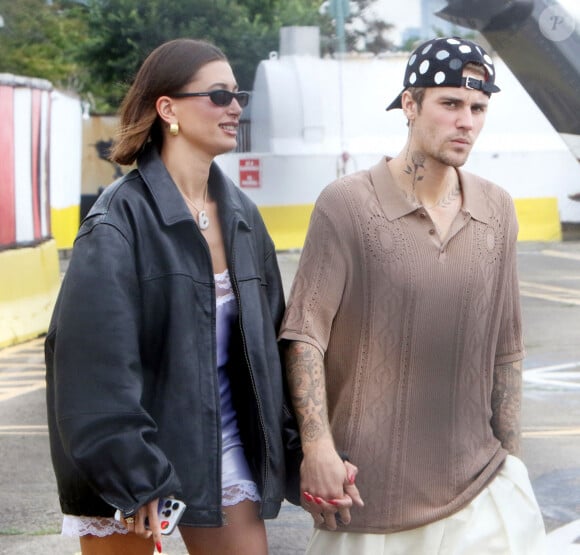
(387, 37, 500, 110)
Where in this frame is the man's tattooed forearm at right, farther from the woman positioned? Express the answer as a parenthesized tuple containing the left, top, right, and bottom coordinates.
(491, 361, 522, 455)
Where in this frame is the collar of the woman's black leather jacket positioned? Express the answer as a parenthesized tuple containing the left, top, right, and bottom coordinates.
(137, 143, 251, 228)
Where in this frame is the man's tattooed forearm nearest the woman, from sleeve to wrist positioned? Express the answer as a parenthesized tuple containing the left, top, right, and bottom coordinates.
(286, 341, 329, 443)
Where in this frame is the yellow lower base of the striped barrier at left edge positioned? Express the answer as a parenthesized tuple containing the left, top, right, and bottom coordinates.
(0, 240, 60, 347)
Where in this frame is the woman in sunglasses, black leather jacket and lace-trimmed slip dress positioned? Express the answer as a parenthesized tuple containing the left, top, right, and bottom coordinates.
(46, 39, 300, 555)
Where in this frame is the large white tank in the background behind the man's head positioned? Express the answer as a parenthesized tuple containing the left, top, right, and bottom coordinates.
(236, 55, 580, 222)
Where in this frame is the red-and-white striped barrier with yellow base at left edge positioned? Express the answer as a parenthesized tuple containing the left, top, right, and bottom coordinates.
(0, 74, 60, 347)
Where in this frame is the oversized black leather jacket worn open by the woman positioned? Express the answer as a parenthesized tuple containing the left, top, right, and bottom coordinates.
(45, 143, 296, 526)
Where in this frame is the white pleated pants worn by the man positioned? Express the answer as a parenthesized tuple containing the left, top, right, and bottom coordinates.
(306, 455, 546, 555)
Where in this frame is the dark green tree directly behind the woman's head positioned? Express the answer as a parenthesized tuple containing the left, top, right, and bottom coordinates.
(81, 0, 329, 111)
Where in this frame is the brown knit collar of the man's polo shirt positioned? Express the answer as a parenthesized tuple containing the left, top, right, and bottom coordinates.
(370, 157, 491, 224)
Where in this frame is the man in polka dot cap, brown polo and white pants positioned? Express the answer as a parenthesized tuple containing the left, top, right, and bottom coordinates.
(280, 38, 545, 555)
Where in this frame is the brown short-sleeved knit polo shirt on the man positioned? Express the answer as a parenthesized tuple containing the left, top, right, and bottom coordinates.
(280, 159, 523, 533)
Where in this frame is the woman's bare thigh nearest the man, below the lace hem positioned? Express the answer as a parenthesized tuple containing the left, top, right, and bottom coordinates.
(179, 500, 268, 555)
